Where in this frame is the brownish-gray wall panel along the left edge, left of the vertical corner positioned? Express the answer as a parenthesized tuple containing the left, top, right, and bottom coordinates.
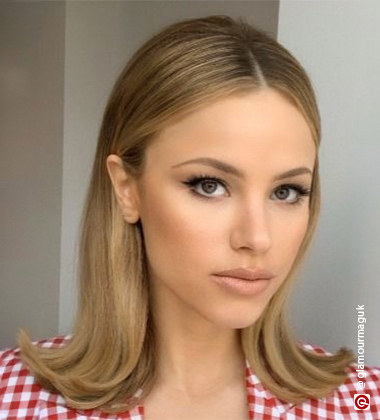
(0, 2, 65, 348)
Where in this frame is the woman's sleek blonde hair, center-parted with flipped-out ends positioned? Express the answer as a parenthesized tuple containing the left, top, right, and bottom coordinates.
(18, 15, 354, 413)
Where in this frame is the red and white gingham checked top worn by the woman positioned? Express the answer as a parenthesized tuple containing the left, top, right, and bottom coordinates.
(0, 335, 380, 420)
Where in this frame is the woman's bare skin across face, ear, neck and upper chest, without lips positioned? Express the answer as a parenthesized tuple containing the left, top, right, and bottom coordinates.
(107, 89, 316, 420)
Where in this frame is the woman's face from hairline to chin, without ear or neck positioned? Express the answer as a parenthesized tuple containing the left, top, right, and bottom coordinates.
(134, 89, 316, 328)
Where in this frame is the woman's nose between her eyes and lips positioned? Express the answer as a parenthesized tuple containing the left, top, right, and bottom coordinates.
(231, 200, 272, 254)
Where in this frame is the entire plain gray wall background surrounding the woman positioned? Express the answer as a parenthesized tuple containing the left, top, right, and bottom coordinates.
(0, 0, 380, 366)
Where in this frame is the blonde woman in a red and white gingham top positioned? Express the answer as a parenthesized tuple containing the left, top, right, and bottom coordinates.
(0, 16, 380, 420)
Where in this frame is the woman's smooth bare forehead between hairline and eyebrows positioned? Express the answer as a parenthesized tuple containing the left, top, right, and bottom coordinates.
(147, 89, 316, 169)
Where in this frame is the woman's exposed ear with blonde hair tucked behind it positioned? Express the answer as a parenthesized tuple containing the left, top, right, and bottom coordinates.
(106, 155, 140, 223)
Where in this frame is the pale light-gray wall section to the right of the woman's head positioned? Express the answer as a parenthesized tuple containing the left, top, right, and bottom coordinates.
(278, 0, 380, 366)
